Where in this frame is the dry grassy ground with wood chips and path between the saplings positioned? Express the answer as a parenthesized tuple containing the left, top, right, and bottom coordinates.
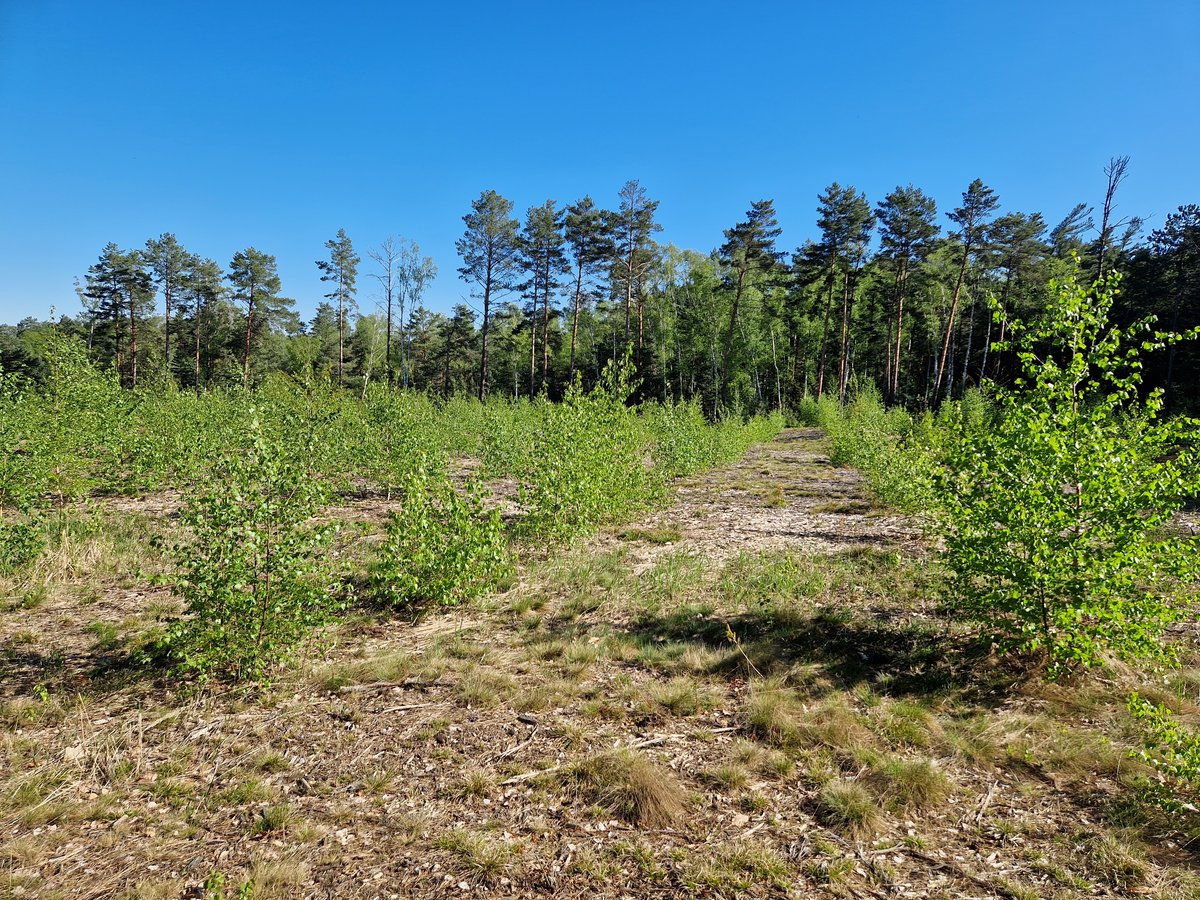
(0, 430, 1200, 900)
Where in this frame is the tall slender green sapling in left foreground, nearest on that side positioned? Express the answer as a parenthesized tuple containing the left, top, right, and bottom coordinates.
(162, 409, 341, 680)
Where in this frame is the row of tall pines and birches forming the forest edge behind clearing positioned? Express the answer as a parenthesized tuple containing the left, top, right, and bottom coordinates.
(0, 157, 1200, 418)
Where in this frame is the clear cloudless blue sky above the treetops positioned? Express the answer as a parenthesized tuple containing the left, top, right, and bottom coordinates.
(0, 0, 1200, 323)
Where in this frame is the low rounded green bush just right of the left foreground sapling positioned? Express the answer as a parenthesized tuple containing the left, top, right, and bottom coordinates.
(371, 469, 511, 606)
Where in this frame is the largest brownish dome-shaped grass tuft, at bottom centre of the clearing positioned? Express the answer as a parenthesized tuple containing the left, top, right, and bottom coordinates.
(563, 750, 689, 828)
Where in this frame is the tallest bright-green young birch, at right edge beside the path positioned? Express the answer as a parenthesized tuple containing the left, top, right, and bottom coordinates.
(938, 256, 1200, 673)
